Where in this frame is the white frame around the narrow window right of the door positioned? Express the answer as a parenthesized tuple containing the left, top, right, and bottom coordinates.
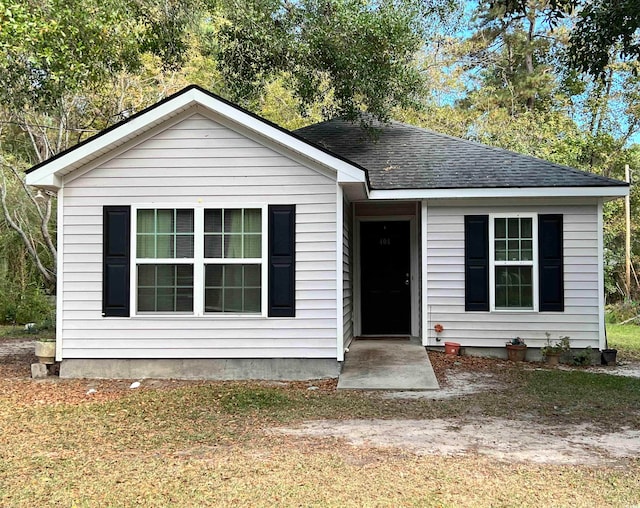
(489, 212, 539, 312)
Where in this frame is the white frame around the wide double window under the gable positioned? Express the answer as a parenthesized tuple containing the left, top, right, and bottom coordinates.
(129, 202, 269, 319)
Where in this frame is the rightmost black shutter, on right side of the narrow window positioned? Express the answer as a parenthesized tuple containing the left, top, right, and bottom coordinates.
(538, 215, 564, 312)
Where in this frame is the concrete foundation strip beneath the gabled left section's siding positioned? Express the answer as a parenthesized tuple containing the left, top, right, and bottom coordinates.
(60, 358, 341, 381)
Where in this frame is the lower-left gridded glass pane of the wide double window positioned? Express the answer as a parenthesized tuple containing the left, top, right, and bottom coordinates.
(138, 265, 193, 312)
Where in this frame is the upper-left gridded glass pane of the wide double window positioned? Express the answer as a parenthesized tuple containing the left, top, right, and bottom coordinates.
(136, 208, 194, 259)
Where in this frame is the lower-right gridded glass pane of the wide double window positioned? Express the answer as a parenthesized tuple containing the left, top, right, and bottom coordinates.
(204, 264, 262, 313)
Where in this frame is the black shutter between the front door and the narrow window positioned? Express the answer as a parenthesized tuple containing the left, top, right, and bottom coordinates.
(464, 215, 489, 311)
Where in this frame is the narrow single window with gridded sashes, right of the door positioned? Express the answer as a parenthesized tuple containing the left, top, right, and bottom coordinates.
(491, 216, 535, 310)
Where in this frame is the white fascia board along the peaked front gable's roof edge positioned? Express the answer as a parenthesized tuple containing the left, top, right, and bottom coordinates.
(27, 89, 365, 188)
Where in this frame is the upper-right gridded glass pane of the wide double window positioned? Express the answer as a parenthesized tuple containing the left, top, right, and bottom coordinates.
(204, 208, 262, 259)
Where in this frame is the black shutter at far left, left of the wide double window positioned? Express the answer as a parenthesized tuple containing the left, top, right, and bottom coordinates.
(102, 206, 131, 317)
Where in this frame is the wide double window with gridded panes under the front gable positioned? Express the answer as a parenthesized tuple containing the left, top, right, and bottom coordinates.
(135, 208, 263, 315)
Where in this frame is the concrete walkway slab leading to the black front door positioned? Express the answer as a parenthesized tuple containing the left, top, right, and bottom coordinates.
(338, 339, 440, 390)
